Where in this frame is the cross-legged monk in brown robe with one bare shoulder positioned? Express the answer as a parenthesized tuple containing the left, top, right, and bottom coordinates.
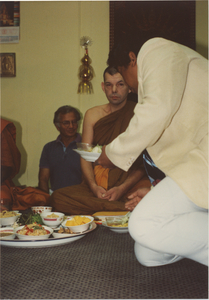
(51, 68, 151, 215)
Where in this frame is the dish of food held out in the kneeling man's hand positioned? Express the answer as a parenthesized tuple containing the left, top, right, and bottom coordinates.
(73, 143, 102, 162)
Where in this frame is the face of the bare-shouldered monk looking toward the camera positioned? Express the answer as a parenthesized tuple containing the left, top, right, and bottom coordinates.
(102, 73, 130, 105)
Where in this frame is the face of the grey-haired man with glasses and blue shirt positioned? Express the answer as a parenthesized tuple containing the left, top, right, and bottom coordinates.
(56, 112, 78, 138)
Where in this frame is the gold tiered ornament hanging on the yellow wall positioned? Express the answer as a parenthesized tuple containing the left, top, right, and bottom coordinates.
(78, 36, 94, 94)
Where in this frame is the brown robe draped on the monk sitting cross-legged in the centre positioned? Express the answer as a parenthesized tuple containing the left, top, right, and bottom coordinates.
(50, 101, 150, 215)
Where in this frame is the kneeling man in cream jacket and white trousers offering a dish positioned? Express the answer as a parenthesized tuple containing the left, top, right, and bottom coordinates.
(98, 38, 208, 266)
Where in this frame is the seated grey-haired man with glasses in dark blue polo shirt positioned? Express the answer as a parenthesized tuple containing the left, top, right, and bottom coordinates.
(38, 105, 82, 193)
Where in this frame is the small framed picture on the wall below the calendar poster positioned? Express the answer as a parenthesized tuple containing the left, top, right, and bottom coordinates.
(0, 53, 16, 77)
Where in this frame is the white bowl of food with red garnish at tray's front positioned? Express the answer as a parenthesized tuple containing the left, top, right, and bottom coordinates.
(14, 223, 53, 240)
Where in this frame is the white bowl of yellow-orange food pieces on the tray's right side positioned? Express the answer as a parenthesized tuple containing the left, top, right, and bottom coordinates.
(62, 216, 94, 233)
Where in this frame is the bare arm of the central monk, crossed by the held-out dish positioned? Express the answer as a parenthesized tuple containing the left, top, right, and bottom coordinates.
(81, 108, 106, 198)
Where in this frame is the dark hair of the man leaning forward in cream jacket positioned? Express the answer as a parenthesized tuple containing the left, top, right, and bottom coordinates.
(107, 39, 147, 69)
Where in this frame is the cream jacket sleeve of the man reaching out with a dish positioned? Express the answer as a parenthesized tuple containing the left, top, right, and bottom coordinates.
(106, 38, 189, 171)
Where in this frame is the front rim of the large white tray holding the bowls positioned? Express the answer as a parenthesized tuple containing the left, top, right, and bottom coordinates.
(0, 222, 97, 248)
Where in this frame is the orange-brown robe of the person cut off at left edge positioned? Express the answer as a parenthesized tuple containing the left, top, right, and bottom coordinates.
(0, 119, 49, 210)
